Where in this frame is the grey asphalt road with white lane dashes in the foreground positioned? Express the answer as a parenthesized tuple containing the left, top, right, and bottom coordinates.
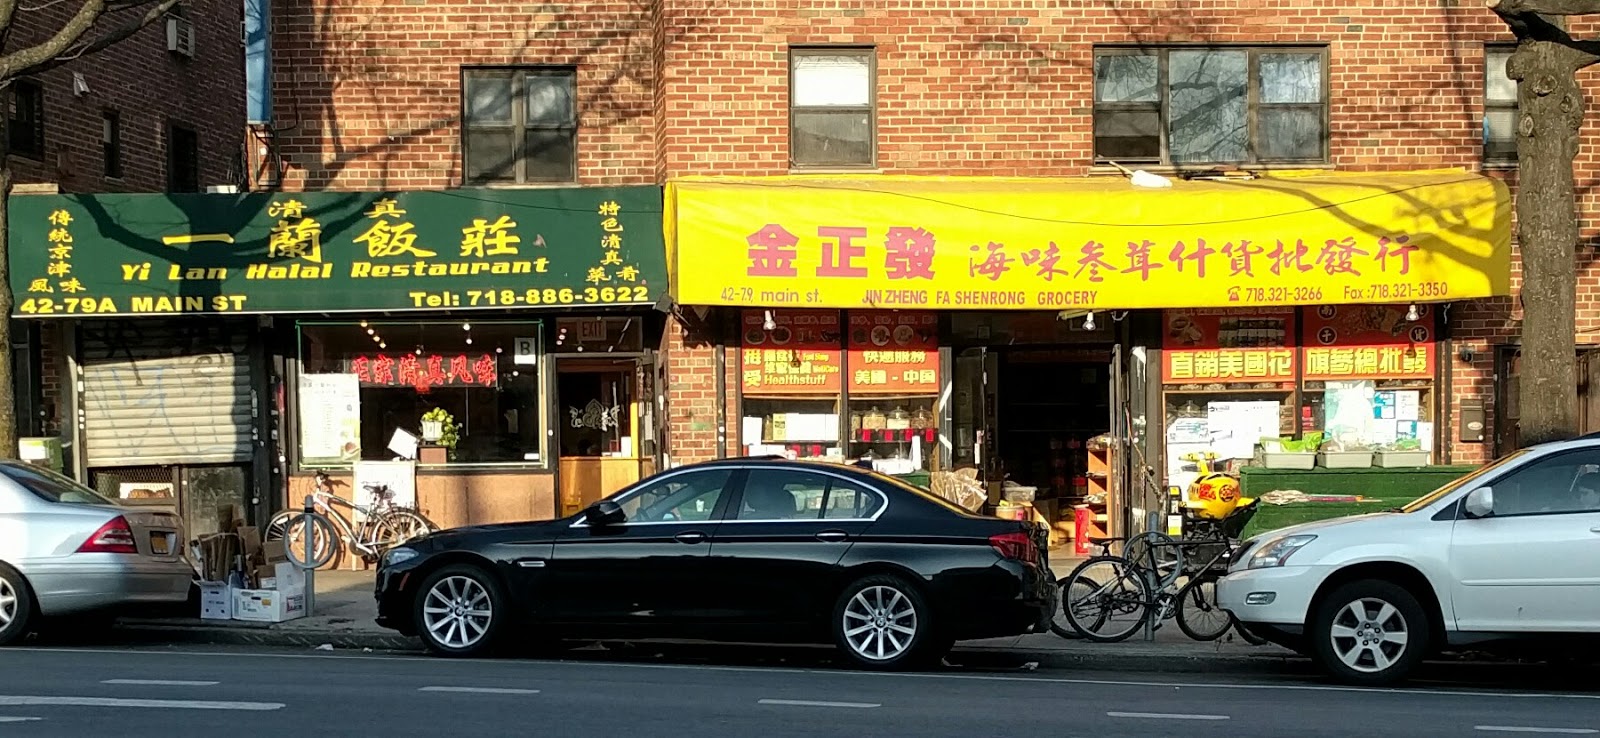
(0, 648, 1600, 738)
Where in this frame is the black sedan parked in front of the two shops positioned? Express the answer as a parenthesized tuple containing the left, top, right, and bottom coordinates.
(378, 459, 1056, 669)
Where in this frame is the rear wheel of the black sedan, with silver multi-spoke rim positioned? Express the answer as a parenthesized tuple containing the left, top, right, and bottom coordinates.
(830, 575, 934, 671)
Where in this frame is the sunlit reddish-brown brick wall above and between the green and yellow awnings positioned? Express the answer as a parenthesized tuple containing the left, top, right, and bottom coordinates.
(256, 0, 1600, 480)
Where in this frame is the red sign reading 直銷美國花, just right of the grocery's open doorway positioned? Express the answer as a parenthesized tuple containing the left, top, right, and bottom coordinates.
(1162, 307, 1296, 384)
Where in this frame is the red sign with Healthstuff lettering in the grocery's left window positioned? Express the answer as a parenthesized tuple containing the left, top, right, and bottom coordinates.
(739, 307, 843, 395)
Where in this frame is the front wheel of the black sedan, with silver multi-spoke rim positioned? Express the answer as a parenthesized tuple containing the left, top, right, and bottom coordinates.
(413, 564, 510, 658)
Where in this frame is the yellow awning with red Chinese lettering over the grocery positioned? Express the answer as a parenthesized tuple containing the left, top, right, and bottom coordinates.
(664, 170, 1510, 311)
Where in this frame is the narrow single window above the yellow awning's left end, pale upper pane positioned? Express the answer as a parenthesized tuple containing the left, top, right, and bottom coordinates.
(789, 48, 877, 166)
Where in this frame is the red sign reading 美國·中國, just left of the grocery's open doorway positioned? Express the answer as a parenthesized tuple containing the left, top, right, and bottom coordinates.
(850, 311, 939, 395)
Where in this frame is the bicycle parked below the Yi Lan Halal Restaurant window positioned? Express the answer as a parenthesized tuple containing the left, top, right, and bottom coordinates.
(266, 472, 438, 568)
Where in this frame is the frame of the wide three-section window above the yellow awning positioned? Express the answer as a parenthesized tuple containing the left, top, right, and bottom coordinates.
(1090, 43, 1333, 170)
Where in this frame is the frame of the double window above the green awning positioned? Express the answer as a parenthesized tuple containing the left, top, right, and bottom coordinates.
(461, 66, 582, 187)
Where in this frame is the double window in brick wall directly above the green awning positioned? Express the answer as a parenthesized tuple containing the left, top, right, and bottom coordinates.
(462, 69, 578, 184)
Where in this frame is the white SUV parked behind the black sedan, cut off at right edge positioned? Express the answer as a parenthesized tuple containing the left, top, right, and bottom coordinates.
(1218, 437, 1600, 685)
